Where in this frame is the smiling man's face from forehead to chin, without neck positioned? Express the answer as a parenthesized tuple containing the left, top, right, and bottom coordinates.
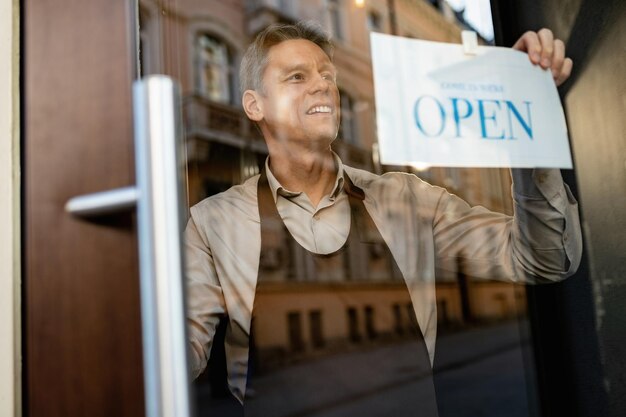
(251, 39, 339, 148)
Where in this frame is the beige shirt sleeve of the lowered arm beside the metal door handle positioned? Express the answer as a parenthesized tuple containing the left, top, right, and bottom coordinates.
(185, 216, 225, 379)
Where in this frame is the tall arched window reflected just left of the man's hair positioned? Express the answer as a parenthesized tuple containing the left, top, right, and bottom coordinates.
(196, 34, 233, 104)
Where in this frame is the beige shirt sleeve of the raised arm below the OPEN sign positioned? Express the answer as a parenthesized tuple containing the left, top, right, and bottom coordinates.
(433, 169, 582, 283)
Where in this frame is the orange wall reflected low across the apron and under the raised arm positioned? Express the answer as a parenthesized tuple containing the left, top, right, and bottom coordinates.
(253, 281, 526, 356)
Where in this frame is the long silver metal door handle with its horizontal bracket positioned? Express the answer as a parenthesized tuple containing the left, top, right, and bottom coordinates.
(65, 75, 190, 417)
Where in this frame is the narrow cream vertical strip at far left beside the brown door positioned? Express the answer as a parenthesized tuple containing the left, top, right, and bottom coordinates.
(0, 0, 21, 417)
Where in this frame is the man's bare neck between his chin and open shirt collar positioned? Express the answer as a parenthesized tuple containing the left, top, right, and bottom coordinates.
(268, 144, 337, 207)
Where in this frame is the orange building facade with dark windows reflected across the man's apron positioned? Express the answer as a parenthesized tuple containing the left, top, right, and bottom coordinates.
(253, 282, 415, 364)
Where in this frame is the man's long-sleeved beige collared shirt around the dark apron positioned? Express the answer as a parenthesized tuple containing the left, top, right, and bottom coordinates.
(185, 158, 582, 391)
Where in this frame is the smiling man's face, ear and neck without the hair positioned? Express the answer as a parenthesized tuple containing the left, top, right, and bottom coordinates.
(243, 33, 339, 207)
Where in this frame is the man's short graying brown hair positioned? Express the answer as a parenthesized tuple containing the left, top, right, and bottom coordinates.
(239, 21, 333, 93)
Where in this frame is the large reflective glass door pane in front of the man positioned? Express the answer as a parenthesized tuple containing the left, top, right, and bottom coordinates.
(133, 0, 604, 416)
